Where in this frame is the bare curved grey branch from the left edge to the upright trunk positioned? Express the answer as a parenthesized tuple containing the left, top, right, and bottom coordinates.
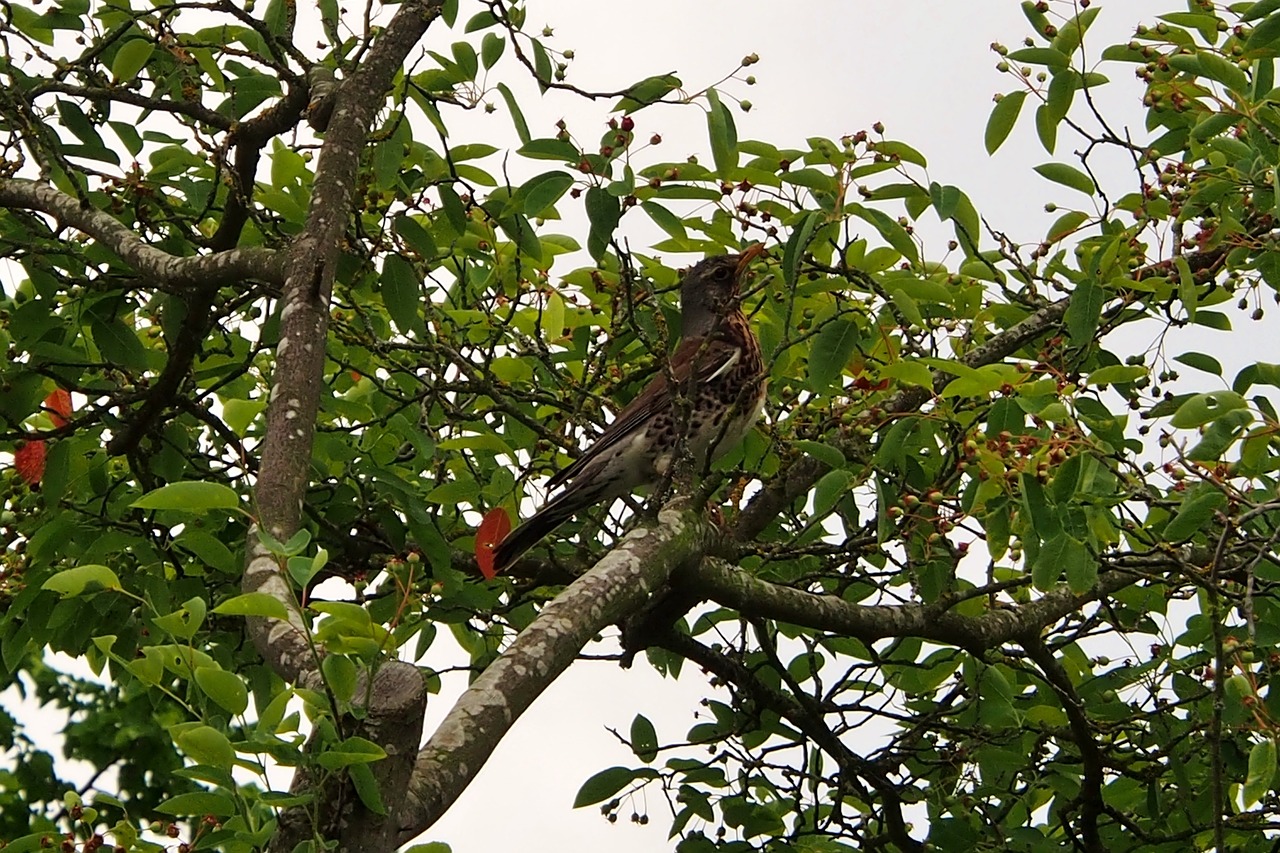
(0, 178, 284, 291)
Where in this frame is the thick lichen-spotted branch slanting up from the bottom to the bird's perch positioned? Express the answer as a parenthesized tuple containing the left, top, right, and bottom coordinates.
(401, 500, 719, 843)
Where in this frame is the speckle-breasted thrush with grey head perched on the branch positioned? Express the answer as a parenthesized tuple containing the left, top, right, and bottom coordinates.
(494, 243, 768, 571)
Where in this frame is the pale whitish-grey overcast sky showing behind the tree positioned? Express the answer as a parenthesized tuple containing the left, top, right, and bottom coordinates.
(4, 0, 1213, 853)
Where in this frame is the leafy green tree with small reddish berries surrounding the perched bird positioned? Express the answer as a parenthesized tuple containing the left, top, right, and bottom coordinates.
(0, 0, 1280, 853)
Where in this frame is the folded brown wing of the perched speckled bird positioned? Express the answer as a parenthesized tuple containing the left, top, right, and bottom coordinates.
(547, 338, 741, 489)
